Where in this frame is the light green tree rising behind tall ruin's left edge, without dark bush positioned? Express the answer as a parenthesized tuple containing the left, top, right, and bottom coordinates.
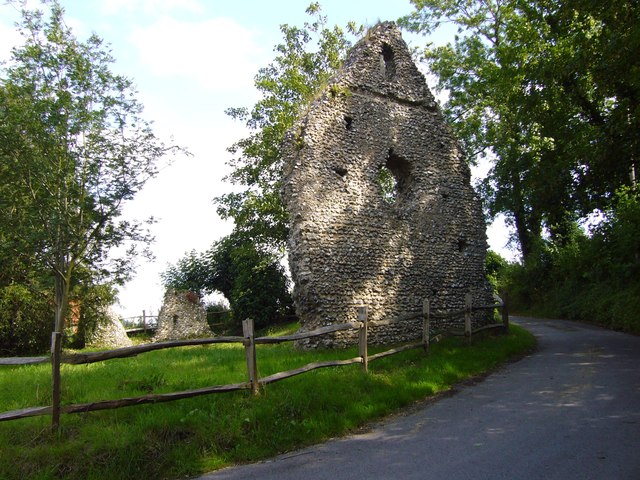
(215, 3, 361, 247)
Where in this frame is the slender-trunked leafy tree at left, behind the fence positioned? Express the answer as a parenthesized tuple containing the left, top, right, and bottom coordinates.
(0, 1, 184, 425)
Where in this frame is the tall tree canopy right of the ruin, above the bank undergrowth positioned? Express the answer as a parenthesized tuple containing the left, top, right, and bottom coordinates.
(403, 0, 640, 262)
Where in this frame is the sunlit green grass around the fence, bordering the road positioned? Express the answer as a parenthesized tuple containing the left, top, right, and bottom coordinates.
(0, 326, 535, 480)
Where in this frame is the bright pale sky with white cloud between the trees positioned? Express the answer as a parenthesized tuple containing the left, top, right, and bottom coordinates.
(0, 0, 506, 316)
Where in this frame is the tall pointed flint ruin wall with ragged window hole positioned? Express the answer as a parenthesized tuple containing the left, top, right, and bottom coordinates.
(282, 23, 492, 347)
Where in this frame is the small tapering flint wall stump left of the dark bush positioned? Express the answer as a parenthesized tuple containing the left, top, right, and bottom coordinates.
(153, 289, 212, 342)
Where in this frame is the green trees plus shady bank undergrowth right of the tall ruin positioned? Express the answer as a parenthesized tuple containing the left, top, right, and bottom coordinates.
(404, 0, 640, 332)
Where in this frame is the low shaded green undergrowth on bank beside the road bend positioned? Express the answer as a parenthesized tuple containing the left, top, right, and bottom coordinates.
(501, 188, 640, 333)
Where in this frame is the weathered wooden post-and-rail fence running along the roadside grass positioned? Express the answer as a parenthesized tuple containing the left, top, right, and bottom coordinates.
(0, 295, 509, 428)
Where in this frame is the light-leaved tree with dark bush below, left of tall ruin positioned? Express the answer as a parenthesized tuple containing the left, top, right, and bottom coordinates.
(163, 3, 359, 326)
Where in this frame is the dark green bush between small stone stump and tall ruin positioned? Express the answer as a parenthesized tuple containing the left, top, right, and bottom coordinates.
(162, 231, 292, 327)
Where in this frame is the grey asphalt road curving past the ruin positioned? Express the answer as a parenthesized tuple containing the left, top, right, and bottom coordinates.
(201, 318, 640, 480)
